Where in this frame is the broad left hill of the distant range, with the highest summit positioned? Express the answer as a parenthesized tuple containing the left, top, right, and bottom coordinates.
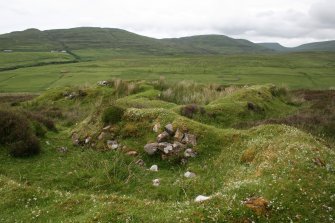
(0, 27, 178, 54)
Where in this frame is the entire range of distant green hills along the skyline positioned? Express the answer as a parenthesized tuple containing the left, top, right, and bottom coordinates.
(0, 27, 335, 55)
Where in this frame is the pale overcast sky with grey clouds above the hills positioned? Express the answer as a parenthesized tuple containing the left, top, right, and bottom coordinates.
(0, 0, 335, 46)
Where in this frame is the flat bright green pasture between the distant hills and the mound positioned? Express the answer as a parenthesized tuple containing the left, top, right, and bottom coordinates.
(0, 49, 335, 92)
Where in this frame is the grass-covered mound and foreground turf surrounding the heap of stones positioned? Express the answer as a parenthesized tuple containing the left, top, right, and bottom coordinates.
(0, 82, 335, 222)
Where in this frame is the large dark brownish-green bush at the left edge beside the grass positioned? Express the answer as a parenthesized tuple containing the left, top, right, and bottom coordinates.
(0, 110, 40, 157)
